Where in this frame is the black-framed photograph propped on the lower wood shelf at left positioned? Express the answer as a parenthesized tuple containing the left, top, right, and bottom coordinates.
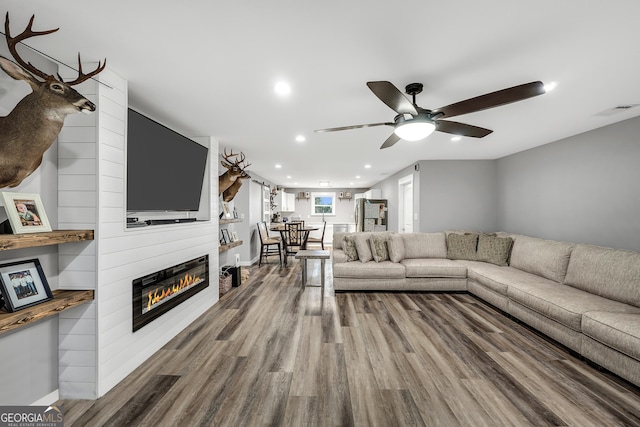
(0, 259, 53, 312)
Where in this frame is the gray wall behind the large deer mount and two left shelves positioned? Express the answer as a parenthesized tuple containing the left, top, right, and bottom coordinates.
(0, 46, 58, 405)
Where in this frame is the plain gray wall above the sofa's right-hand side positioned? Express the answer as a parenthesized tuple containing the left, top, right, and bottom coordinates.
(497, 118, 640, 251)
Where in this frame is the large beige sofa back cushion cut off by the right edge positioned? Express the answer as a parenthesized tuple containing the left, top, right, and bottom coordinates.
(564, 244, 640, 307)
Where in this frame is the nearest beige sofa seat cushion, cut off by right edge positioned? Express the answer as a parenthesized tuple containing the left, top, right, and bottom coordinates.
(582, 309, 640, 360)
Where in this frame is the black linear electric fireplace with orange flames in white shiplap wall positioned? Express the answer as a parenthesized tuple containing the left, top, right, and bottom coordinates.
(132, 255, 209, 332)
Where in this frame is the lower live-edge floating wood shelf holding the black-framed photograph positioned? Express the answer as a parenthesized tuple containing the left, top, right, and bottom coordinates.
(0, 289, 94, 334)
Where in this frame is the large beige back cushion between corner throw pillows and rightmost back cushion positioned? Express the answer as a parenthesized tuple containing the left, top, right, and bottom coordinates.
(510, 235, 575, 283)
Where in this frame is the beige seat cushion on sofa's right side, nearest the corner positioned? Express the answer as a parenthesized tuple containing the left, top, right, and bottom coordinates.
(457, 261, 544, 296)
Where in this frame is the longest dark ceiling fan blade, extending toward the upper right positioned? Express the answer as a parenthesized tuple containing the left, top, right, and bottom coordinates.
(433, 82, 545, 117)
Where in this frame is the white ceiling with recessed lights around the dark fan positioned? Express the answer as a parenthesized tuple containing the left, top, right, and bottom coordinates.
(3, 0, 640, 188)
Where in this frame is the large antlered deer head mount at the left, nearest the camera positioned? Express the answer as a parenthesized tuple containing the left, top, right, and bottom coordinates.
(0, 12, 107, 188)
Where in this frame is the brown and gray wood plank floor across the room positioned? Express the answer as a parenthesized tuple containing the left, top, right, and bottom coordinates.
(58, 260, 640, 427)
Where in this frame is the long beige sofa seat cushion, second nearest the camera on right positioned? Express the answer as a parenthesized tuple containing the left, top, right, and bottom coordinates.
(507, 279, 637, 332)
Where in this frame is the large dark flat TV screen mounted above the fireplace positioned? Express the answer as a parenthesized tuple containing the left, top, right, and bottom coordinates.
(127, 109, 209, 212)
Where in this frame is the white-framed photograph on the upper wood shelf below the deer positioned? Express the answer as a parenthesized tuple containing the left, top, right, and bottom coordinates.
(0, 191, 51, 234)
